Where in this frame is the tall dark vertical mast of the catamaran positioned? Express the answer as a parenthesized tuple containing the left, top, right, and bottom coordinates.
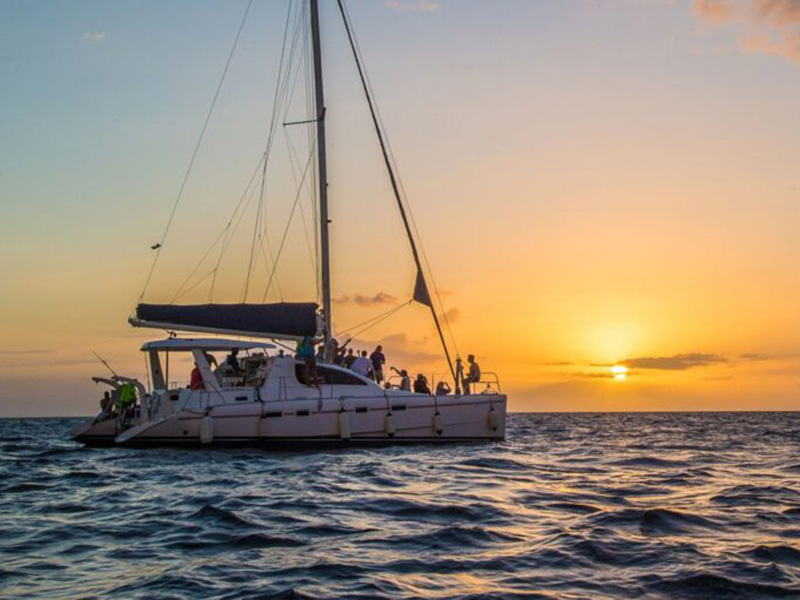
(309, 0, 333, 342)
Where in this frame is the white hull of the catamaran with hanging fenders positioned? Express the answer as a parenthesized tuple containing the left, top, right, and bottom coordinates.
(75, 394, 506, 446)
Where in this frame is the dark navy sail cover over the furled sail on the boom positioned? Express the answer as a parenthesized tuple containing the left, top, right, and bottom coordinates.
(132, 302, 317, 338)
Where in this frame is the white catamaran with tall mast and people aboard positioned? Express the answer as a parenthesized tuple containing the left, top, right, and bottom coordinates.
(73, 0, 506, 447)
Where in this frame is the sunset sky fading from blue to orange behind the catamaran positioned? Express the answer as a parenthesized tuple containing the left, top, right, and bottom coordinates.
(0, 0, 800, 416)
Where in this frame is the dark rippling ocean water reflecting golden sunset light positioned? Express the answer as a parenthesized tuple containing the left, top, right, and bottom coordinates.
(0, 413, 800, 599)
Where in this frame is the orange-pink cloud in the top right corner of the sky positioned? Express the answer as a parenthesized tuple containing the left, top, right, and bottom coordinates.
(692, 0, 800, 62)
